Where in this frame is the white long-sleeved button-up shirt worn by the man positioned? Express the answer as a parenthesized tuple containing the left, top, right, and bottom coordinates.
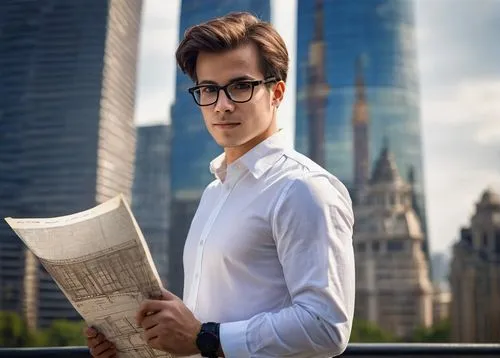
(183, 132, 355, 358)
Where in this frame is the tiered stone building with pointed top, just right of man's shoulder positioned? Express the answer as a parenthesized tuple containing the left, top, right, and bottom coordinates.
(354, 144, 433, 338)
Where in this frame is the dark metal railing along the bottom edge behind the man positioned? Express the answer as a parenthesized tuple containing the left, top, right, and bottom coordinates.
(0, 343, 500, 358)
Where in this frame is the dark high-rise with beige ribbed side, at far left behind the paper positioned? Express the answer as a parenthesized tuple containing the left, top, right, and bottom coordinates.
(0, 0, 142, 326)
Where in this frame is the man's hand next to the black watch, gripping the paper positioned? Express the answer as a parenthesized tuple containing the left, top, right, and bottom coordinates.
(136, 289, 201, 356)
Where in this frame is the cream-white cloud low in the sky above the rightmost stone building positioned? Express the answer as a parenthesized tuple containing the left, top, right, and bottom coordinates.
(422, 81, 500, 251)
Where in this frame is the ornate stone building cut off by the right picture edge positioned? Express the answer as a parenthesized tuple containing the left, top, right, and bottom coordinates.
(450, 189, 500, 342)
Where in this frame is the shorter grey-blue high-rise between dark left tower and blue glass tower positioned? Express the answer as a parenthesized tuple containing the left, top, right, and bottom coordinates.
(132, 124, 170, 286)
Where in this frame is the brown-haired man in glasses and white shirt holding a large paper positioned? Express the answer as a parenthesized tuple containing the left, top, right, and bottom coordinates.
(88, 13, 355, 358)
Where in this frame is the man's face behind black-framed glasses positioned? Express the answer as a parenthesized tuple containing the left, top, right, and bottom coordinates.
(196, 44, 284, 148)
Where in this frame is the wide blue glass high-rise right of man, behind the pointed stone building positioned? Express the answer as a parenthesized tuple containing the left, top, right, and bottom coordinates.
(295, 0, 429, 257)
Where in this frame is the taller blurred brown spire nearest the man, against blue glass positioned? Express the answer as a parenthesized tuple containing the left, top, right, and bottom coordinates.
(306, 0, 330, 166)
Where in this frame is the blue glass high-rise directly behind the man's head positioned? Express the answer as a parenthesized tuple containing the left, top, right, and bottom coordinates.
(168, 0, 271, 296)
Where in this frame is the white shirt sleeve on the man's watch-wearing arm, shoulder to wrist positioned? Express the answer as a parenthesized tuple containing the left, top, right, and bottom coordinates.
(220, 173, 355, 358)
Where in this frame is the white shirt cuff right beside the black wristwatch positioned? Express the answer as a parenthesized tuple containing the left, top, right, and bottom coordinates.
(219, 321, 250, 358)
